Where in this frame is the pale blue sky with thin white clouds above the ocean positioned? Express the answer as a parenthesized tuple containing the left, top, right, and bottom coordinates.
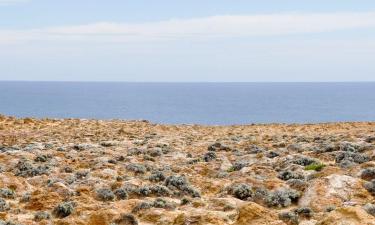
(0, 0, 375, 82)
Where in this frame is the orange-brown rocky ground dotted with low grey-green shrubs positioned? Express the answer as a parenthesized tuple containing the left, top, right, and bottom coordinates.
(0, 116, 375, 225)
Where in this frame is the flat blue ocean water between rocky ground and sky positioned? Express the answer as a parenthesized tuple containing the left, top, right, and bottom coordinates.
(0, 82, 375, 125)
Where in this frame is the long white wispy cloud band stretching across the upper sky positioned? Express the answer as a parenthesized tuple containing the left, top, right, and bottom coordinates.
(0, 11, 375, 43)
